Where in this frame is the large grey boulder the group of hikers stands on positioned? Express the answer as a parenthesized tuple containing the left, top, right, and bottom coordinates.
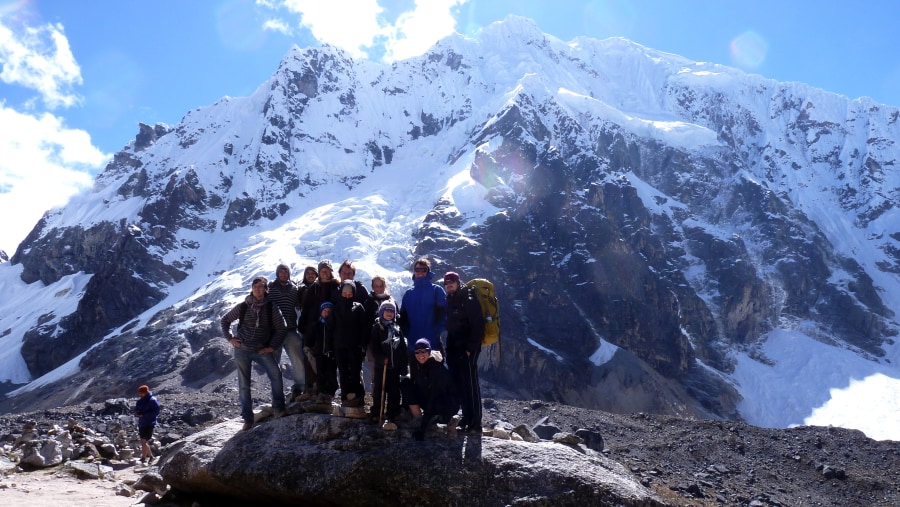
(160, 414, 663, 506)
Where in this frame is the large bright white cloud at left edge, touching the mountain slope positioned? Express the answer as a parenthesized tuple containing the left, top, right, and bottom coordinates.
(0, 102, 108, 255)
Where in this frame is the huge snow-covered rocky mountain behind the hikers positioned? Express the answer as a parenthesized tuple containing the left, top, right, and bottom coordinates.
(0, 17, 900, 438)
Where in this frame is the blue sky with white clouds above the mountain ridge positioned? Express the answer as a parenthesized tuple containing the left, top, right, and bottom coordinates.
(0, 0, 900, 255)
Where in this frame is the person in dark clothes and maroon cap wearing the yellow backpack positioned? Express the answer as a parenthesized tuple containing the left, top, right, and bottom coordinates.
(444, 271, 484, 435)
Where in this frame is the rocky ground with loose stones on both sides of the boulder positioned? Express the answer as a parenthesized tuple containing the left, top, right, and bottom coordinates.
(0, 384, 900, 507)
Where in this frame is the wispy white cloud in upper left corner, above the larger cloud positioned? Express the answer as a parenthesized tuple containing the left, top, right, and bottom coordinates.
(0, 18, 81, 109)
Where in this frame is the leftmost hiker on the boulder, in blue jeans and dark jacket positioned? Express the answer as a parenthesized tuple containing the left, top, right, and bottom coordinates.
(222, 276, 287, 430)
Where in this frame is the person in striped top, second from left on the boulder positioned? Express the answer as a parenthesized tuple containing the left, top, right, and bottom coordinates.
(269, 264, 306, 400)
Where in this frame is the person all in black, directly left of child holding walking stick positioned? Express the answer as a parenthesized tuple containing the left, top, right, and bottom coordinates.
(323, 280, 369, 407)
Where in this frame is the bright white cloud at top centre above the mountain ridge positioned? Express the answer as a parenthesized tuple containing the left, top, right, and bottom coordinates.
(257, 0, 468, 62)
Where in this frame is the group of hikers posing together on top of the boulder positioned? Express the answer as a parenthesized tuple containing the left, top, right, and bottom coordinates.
(221, 257, 484, 439)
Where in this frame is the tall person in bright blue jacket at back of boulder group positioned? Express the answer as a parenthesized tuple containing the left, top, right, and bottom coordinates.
(400, 257, 447, 358)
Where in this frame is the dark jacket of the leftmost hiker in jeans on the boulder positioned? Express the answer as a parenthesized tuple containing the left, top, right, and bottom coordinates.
(221, 295, 287, 352)
